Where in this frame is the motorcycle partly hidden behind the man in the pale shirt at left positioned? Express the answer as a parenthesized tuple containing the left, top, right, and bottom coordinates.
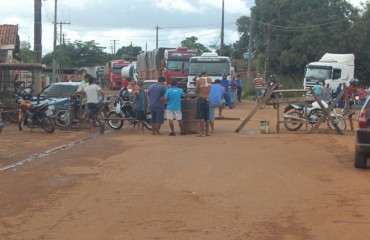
(55, 96, 111, 128)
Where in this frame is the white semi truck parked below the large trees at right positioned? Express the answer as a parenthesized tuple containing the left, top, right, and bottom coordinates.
(303, 53, 355, 91)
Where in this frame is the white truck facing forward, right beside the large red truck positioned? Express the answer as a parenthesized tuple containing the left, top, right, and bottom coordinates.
(187, 52, 232, 97)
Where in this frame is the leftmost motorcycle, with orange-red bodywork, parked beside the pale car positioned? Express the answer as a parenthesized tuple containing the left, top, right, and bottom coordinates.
(17, 88, 55, 133)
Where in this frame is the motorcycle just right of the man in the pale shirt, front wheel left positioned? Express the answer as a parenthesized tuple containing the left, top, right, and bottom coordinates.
(107, 96, 152, 130)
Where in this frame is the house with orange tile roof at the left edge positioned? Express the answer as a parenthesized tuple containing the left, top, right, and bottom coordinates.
(0, 24, 20, 63)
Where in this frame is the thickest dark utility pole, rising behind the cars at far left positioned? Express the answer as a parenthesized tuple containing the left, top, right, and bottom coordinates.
(33, 0, 42, 92)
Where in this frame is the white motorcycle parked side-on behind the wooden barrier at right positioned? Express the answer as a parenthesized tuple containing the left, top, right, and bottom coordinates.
(283, 101, 347, 131)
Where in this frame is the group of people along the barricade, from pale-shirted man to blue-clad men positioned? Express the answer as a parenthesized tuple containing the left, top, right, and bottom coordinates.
(78, 71, 243, 137)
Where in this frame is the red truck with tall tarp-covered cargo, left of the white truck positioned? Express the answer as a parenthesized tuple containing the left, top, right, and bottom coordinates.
(137, 47, 199, 91)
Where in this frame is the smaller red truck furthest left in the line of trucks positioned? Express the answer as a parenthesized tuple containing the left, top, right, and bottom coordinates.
(104, 60, 130, 90)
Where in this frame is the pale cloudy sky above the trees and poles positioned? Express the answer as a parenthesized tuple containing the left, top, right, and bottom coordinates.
(0, 0, 365, 54)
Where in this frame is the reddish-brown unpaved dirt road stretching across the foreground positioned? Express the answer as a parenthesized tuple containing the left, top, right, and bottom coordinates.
(0, 102, 370, 240)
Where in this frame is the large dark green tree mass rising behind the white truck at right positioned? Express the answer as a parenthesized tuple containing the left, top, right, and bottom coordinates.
(241, 0, 358, 76)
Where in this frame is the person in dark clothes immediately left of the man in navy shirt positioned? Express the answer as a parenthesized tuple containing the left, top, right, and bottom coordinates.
(133, 81, 149, 133)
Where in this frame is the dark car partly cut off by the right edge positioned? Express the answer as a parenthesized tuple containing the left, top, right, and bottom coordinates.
(355, 98, 370, 168)
